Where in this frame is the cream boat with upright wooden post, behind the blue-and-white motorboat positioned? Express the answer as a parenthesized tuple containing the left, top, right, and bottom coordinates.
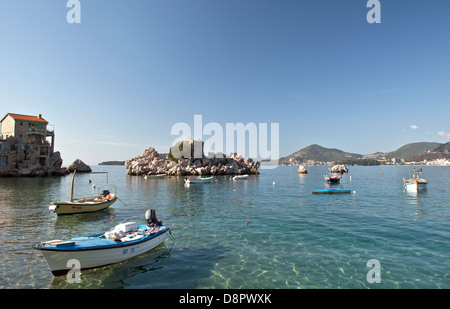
(48, 170, 117, 215)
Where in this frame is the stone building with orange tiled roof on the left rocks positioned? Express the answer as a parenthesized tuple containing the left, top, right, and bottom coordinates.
(0, 113, 59, 173)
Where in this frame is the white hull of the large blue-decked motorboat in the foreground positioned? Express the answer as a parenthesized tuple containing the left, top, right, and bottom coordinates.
(36, 228, 169, 276)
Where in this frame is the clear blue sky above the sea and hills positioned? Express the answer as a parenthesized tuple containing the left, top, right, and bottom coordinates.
(0, 0, 450, 165)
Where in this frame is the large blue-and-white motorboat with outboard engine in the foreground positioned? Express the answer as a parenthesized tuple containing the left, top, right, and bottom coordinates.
(34, 210, 170, 276)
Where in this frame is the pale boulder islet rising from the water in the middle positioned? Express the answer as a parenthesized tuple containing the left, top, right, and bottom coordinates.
(125, 141, 260, 176)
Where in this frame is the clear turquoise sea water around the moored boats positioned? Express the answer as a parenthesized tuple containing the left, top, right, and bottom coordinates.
(0, 166, 450, 289)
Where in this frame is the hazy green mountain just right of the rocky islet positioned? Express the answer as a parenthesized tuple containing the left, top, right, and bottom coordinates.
(280, 144, 362, 164)
